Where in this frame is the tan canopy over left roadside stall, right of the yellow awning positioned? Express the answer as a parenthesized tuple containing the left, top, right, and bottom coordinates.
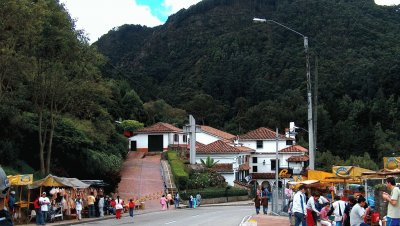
(28, 174, 89, 189)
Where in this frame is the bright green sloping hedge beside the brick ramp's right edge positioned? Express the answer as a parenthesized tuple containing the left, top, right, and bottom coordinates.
(167, 150, 189, 190)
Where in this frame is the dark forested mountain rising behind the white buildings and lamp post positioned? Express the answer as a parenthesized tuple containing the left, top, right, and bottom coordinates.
(94, 0, 400, 163)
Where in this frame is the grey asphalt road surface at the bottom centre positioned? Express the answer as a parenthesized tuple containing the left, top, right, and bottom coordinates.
(74, 206, 255, 226)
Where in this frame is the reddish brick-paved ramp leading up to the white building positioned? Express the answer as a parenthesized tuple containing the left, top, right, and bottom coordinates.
(117, 152, 164, 210)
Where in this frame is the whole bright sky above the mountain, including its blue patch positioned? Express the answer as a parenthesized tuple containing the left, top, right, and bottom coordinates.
(60, 0, 400, 43)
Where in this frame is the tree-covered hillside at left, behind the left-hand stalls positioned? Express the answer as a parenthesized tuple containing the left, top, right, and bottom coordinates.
(0, 0, 144, 189)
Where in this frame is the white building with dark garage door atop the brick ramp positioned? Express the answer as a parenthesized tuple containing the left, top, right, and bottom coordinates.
(129, 122, 187, 152)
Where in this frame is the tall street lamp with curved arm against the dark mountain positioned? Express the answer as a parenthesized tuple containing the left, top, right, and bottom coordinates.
(253, 18, 315, 170)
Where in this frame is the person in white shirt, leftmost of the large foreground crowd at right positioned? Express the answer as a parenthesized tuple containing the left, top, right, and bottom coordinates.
(292, 184, 307, 226)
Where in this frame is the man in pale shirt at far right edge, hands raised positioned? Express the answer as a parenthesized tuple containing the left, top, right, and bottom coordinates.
(382, 177, 400, 226)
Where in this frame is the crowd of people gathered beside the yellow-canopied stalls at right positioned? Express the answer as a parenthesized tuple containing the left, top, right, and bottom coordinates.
(280, 177, 400, 226)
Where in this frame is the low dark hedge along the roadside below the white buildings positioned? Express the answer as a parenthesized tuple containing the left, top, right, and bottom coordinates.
(179, 187, 248, 200)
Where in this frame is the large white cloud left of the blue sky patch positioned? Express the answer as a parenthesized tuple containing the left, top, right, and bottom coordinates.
(60, 0, 163, 42)
